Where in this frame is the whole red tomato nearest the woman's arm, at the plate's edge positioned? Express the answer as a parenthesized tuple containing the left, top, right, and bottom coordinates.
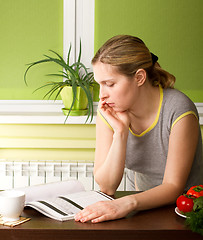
(176, 195, 194, 212)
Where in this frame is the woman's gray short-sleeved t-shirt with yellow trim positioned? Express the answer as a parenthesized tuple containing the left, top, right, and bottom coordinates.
(126, 88, 203, 191)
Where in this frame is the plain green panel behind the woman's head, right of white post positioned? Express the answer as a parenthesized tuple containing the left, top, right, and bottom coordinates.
(95, 0, 203, 102)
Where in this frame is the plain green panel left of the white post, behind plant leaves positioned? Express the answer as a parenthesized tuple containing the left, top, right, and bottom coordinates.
(0, 0, 63, 100)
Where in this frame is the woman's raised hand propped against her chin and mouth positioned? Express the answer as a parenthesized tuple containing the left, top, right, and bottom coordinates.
(99, 100, 130, 132)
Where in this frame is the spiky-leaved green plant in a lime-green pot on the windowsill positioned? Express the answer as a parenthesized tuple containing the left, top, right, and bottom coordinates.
(24, 41, 95, 122)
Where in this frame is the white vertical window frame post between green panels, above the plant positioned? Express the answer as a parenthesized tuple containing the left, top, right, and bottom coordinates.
(63, 0, 95, 71)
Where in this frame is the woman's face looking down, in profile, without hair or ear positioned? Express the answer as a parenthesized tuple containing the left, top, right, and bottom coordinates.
(93, 62, 138, 112)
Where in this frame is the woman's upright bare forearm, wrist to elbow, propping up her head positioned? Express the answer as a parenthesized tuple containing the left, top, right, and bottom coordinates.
(94, 133, 128, 195)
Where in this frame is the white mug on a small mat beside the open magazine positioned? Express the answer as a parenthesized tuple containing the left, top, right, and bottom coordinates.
(0, 190, 25, 221)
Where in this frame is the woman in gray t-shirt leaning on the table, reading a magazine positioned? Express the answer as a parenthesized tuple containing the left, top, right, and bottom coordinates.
(75, 35, 203, 223)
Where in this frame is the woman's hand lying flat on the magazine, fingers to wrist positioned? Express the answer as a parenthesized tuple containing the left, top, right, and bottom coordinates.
(75, 196, 135, 223)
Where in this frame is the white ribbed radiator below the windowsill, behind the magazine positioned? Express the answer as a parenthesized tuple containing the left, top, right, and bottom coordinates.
(0, 159, 132, 191)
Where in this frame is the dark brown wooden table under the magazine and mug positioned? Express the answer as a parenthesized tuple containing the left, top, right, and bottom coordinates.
(0, 192, 203, 240)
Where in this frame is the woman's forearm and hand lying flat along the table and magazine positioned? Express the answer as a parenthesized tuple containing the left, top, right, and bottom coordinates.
(75, 183, 184, 223)
